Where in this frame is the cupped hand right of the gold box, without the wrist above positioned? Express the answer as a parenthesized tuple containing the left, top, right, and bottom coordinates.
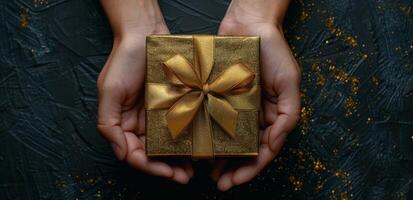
(212, 21, 300, 190)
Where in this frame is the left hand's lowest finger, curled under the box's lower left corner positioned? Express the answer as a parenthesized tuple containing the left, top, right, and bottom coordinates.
(125, 132, 174, 178)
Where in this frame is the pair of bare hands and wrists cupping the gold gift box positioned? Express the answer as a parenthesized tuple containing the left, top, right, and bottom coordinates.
(97, 0, 300, 191)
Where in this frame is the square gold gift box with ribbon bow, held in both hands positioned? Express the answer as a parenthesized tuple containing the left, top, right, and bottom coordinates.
(145, 35, 261, 158)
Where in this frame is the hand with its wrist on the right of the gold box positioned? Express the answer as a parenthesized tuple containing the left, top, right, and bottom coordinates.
(212, 0, 300, 191)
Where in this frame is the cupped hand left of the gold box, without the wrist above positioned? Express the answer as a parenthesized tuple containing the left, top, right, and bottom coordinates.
(97, 23, 193, 183)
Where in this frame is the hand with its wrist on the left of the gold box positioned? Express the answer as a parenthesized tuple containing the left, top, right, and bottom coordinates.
(97, 0, 193, 183)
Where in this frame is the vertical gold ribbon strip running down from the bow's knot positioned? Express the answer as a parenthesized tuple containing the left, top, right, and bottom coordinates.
(192, 101, 214, 159)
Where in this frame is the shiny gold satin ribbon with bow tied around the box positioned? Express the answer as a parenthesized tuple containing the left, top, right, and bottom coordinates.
(145, 35, 260, 158)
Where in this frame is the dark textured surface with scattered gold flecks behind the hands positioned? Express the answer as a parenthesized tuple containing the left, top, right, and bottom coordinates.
(0, 0, 413, 199)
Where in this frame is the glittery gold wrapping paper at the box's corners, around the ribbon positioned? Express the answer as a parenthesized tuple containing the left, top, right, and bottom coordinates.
(146, 35, 260, 157)
